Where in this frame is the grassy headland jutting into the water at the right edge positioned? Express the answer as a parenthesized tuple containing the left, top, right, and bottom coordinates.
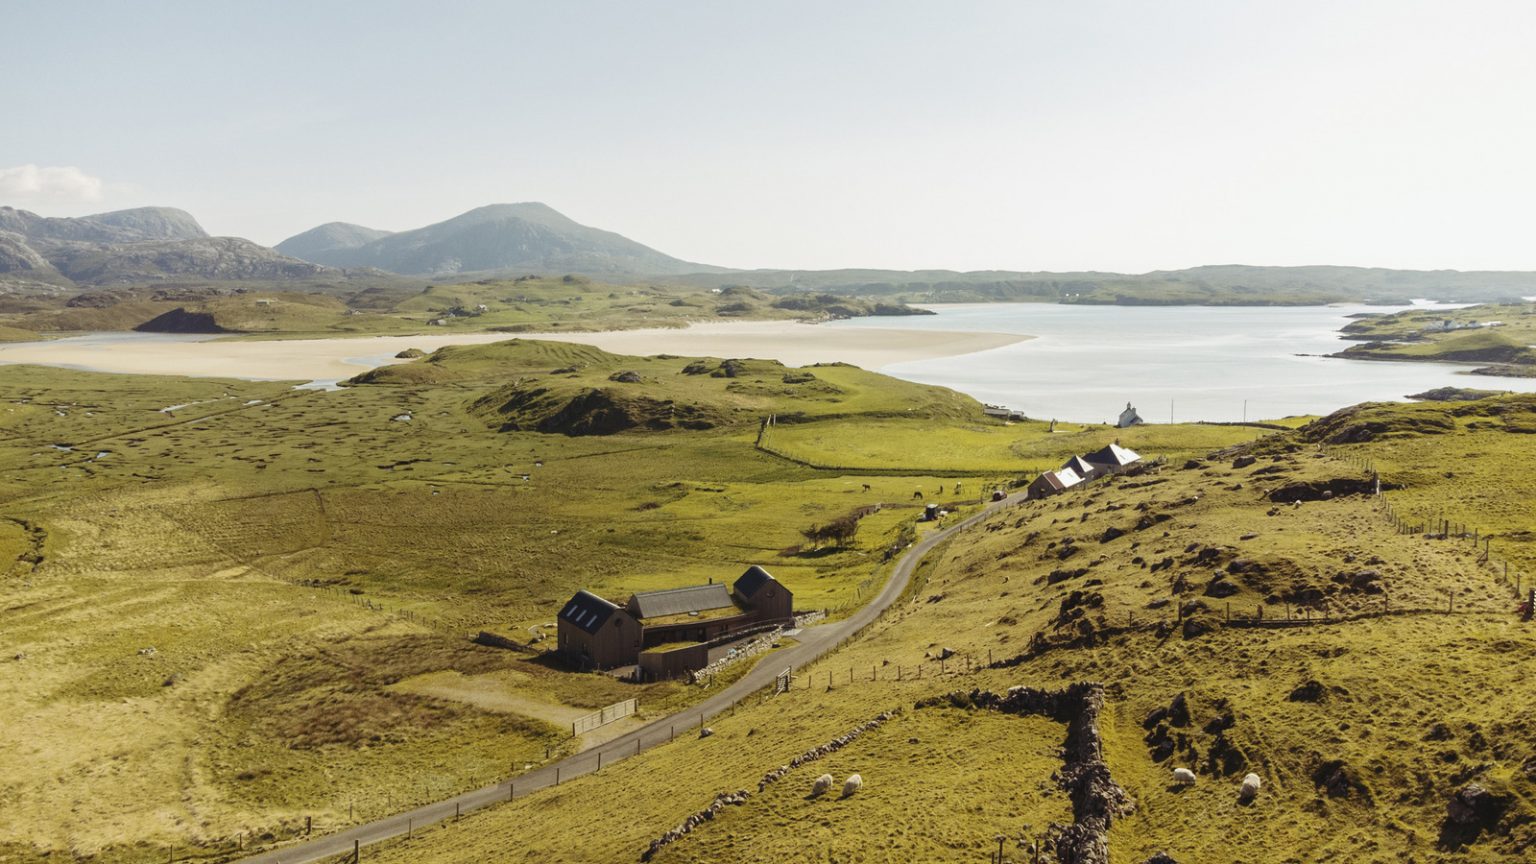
(1333, 303, 1536, 377)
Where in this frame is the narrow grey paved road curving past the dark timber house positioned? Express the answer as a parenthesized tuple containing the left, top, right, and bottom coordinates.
(241, 493, 1023, 864)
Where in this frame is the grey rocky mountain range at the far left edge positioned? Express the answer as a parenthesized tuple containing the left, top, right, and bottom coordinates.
(0, 208, 332, 291)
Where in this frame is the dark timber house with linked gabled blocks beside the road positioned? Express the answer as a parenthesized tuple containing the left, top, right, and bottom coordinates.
(558, 564, 794, 678)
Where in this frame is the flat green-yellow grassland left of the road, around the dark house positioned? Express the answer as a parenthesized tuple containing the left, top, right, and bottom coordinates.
(0, 333, 1247, 861)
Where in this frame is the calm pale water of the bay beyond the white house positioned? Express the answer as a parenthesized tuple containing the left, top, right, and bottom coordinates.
(828, 303, 1536, 423)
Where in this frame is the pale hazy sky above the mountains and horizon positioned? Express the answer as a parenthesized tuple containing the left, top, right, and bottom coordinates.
(0, 0, 1536, 272)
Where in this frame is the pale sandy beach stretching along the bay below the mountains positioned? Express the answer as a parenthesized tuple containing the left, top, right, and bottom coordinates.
(0, 321, 1031, 381)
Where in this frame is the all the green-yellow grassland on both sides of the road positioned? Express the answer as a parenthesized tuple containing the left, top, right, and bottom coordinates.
(0, 333, 1536, 864)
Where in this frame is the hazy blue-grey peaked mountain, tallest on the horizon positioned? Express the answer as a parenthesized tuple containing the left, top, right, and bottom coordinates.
(278, 201, 723, 275)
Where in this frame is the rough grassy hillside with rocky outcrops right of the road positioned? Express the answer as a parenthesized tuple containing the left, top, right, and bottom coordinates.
(362, 397, 1536, 864)
